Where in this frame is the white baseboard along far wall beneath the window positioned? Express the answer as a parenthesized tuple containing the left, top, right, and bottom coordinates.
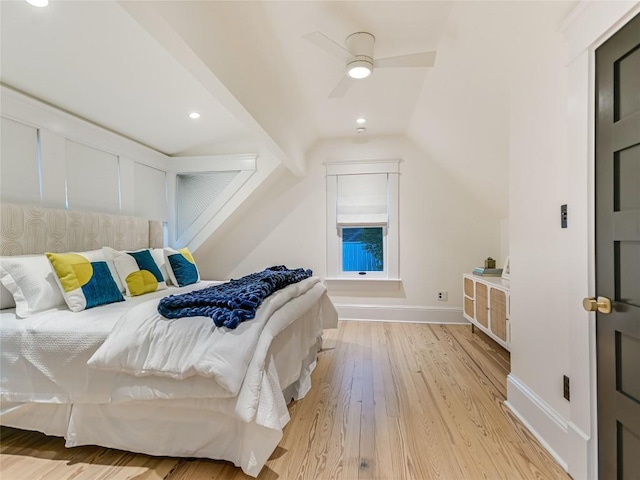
(335, 303, 469, 325)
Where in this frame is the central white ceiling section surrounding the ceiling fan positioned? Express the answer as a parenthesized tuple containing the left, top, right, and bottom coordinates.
(258, 1, 452, 138)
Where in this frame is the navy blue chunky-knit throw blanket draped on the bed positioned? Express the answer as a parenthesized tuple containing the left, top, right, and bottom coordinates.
(158, 265, 312, 328)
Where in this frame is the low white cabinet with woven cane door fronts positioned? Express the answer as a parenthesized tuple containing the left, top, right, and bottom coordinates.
(462, 273, 511, 350)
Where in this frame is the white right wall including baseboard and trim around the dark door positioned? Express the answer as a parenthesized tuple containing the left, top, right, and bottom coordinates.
(507, 2, 640, 479)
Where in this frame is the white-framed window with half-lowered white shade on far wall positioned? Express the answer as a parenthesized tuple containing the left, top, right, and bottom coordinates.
(327, 160, 399, 280)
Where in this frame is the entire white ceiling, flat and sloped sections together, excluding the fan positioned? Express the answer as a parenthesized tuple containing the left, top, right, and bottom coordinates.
(0, 0, 577, 215)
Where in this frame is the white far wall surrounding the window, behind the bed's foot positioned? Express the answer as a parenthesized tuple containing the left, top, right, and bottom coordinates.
(196, 136, 500, 320)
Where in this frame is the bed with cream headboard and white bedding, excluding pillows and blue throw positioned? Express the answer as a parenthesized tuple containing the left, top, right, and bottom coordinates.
(0, 203, 337, 477)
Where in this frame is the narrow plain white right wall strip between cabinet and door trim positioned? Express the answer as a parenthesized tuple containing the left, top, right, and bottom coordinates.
(509, 4, 586, 466)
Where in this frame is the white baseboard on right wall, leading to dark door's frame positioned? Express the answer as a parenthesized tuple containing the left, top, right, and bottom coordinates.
(505, 374, 571, 472)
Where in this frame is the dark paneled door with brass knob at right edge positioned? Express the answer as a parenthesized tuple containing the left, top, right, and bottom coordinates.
(596, 11, 640, 480)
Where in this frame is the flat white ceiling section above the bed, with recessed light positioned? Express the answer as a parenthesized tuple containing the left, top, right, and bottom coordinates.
(0, 0, 254, 154)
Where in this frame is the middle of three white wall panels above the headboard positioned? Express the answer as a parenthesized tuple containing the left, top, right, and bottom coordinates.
(66, 140, 120, 213)
